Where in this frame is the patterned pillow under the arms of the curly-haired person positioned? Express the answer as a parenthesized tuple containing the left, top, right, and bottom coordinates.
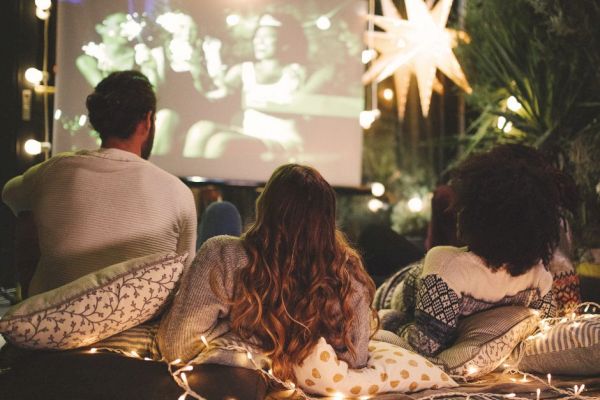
(429, 306, 539, 379)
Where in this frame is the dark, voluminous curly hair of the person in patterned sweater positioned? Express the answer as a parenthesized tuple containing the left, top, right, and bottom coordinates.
(451, 144, 575, 276)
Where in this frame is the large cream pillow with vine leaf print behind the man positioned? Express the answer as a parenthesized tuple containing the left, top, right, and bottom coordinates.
(0, 252, 187, 349)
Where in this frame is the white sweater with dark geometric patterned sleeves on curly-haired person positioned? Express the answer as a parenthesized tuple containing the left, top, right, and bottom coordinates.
(384, 246, 555, 355)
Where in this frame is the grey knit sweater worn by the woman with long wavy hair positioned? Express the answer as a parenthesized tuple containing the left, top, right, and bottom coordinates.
(158, 236, 371, 368)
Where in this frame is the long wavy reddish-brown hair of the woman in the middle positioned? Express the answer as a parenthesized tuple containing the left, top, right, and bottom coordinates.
(231, 164, 377, 380)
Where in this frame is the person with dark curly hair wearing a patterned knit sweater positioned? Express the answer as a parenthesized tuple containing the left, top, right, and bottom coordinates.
(378, 144, 575, 355)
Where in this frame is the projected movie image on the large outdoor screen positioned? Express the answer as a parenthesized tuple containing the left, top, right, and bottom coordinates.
(54, 0, 366, 185)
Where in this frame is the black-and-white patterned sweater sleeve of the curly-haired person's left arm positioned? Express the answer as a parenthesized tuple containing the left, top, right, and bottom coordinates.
(399, 274, 460, 355)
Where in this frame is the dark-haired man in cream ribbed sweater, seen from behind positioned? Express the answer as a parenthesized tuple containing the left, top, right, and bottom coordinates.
(2, 71, 197, 295)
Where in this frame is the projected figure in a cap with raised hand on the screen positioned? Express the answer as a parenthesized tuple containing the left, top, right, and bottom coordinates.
(183, 14, 307, 161)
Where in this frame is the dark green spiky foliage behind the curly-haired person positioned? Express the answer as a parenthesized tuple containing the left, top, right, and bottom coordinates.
(460, 0, 600, 250)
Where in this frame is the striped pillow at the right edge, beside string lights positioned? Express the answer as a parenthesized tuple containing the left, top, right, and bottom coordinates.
(519, 315, 600, 375)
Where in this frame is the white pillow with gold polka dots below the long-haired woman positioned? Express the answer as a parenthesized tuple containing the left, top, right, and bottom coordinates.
(294, 338, 458, 397)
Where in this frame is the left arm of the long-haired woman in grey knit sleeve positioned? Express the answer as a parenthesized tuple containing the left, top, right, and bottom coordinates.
(157, 238, 234, 361)
